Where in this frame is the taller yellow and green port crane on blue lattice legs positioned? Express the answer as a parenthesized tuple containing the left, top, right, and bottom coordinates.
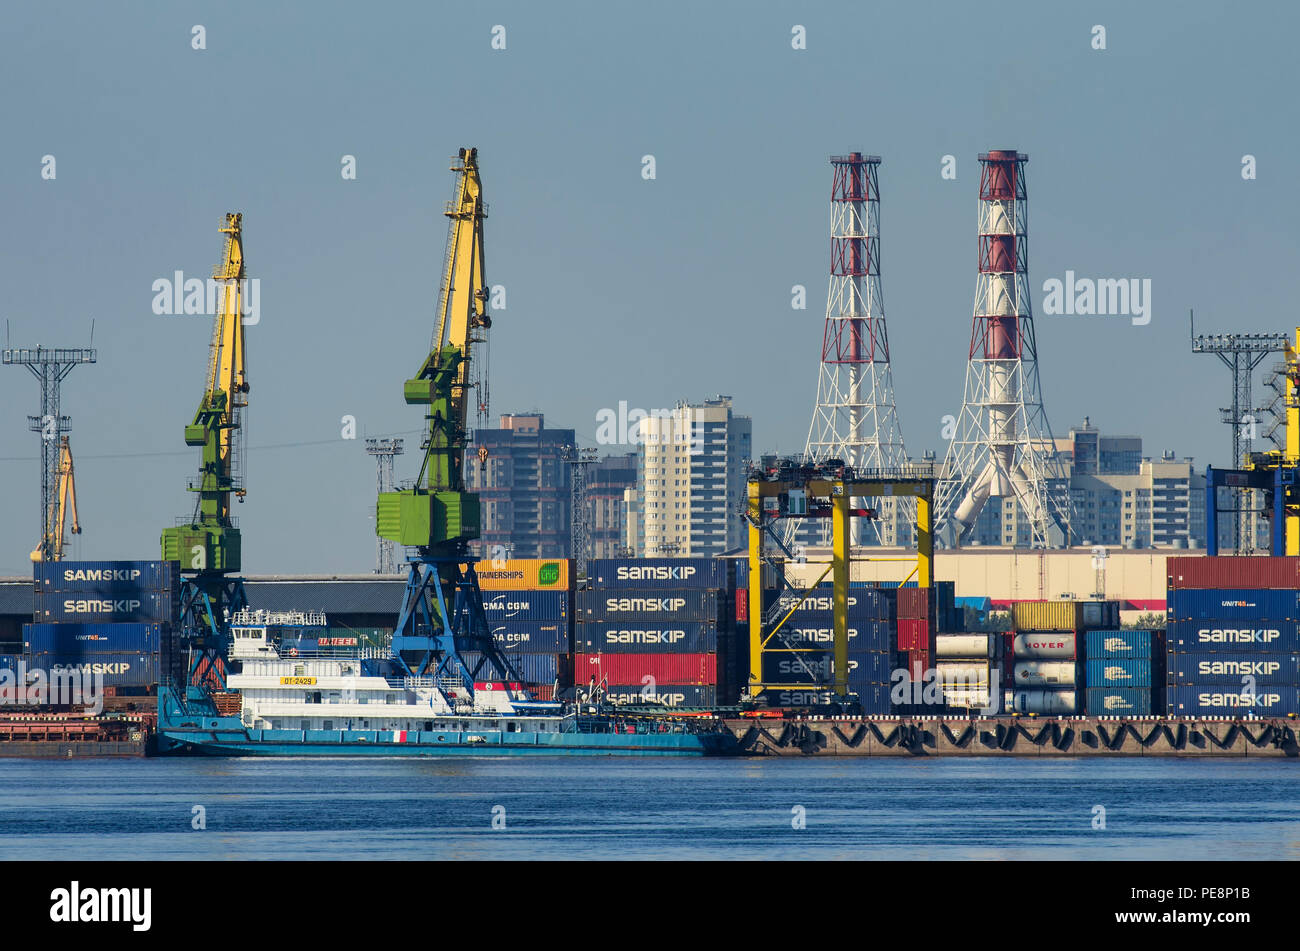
(376, 148, 528, 699)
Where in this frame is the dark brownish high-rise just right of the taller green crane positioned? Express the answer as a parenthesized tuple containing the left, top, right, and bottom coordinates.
(465, 413, 575, 559)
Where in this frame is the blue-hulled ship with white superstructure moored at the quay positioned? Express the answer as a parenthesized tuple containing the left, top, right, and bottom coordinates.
(157, 612, 737, 756)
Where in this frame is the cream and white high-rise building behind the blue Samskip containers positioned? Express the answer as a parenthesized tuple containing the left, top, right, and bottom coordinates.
(624, 396, 753, 557)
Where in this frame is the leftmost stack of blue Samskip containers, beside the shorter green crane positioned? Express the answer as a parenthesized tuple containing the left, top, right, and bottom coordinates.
(23, 561, 185, 694)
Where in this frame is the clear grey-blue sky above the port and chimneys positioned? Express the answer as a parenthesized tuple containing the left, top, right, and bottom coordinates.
(0, 3, 1300, 574)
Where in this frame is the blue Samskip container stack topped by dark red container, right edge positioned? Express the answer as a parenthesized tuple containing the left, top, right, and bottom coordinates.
(1165, 556, 1300, 717)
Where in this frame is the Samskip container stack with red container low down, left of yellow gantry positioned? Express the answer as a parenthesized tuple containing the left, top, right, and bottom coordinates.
(573, 559, 738, 707)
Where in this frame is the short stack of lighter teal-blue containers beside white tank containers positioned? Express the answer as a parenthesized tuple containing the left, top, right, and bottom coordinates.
(1084, 630, 1164, 717)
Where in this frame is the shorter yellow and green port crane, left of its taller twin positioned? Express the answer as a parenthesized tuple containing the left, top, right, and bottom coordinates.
(161, 212, 248, 687)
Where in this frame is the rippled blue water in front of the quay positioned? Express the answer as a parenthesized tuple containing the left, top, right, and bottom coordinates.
(0, 757, 1300, 859)
